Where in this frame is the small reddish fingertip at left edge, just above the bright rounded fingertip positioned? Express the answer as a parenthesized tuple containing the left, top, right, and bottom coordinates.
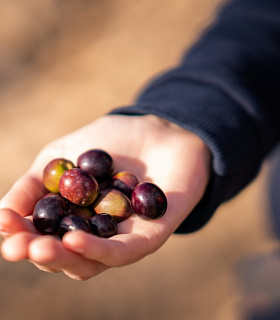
(0, 209, 37, 237)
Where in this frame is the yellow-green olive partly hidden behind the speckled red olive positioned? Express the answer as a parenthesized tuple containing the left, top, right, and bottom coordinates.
(43, 158, 74, 193)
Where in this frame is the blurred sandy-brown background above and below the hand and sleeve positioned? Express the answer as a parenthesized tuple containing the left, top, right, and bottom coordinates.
(0, 0, 278, 320)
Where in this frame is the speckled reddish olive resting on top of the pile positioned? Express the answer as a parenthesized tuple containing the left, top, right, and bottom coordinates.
(59, 168, 99, 207)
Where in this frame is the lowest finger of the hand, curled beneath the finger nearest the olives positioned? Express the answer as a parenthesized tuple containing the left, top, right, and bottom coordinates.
(28, 236, 108, 280)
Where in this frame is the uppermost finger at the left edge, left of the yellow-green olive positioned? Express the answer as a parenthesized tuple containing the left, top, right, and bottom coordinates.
(0, 174, 46, 216)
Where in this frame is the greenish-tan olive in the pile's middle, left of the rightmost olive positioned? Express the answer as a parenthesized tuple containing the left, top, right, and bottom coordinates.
(93, 188, 132, 222)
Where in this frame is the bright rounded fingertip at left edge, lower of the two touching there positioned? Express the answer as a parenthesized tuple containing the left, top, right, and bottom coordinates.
(1, 232, 38, 262)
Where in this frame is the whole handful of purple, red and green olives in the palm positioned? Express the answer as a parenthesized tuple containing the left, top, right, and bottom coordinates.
(33, 149, 167, 238)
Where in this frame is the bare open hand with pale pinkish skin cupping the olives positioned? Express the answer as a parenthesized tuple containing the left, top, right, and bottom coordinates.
(0, 115, 211, 280)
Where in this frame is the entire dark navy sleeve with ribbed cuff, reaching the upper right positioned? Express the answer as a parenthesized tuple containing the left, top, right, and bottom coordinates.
(108, 0, 280, 233)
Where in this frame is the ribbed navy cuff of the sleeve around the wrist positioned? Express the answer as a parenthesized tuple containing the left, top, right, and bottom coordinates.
(110, 78, 260, 233)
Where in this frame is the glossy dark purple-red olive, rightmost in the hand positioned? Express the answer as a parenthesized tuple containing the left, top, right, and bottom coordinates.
(131, 182, 167, 219)
